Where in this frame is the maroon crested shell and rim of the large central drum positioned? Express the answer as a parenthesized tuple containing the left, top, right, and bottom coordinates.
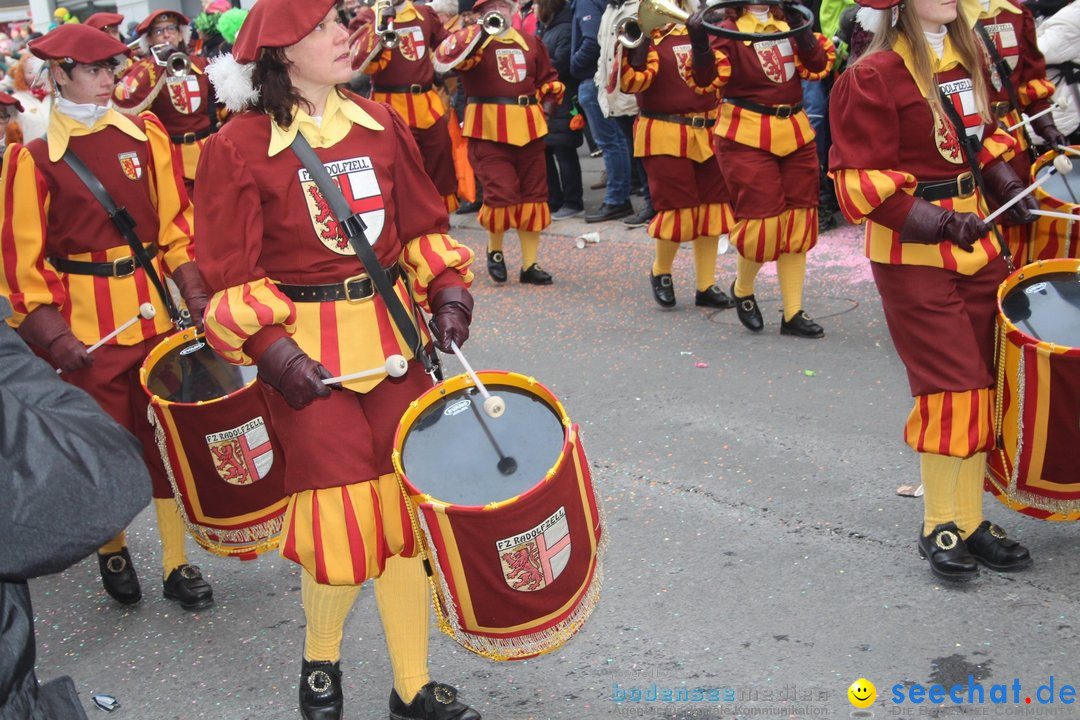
(393, 371, 603, 660)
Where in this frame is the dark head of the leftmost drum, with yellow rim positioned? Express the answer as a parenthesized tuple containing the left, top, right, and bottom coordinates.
(145, 336, 257, 403)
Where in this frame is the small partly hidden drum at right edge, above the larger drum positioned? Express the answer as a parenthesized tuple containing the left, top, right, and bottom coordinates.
(1015, 148, 1080, 266)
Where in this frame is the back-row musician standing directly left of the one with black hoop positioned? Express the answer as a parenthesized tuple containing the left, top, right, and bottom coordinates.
(620, 7, 734, 308)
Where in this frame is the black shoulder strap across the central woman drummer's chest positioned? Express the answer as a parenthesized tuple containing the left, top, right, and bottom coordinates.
(289, 133, 437, 373)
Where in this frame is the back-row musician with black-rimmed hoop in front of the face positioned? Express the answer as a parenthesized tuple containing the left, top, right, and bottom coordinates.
(683, 0, 836, 338)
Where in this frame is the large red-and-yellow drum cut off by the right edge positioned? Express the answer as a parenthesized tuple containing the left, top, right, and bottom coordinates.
(986, 259, 1080, 520)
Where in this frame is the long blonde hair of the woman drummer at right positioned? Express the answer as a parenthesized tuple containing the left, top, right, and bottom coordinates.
(855, 0, 993, 129)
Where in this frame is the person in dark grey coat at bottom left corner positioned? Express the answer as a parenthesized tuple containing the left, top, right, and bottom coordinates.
(0, 296, 150, 720)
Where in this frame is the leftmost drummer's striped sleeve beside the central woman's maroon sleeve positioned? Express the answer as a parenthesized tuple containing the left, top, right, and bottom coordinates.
(140, 112, 195, 273)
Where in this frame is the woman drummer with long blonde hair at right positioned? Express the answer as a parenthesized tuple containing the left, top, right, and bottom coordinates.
(829, 0, 1034, 580)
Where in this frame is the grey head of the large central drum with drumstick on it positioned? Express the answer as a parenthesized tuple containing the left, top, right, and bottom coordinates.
(402, 383, 566, 505)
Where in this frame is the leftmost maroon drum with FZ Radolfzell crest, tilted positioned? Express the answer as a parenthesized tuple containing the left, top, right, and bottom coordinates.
(139, 328, 288, 559)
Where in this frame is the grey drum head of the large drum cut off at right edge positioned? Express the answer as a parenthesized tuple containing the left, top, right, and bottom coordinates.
(1001, 272, 1080, 348)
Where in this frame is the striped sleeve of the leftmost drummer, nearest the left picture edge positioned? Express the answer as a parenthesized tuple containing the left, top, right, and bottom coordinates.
(0, 145, 67, 327)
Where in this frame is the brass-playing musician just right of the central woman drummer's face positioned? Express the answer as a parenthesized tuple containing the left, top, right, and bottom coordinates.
(353, 0, 458, 212)
